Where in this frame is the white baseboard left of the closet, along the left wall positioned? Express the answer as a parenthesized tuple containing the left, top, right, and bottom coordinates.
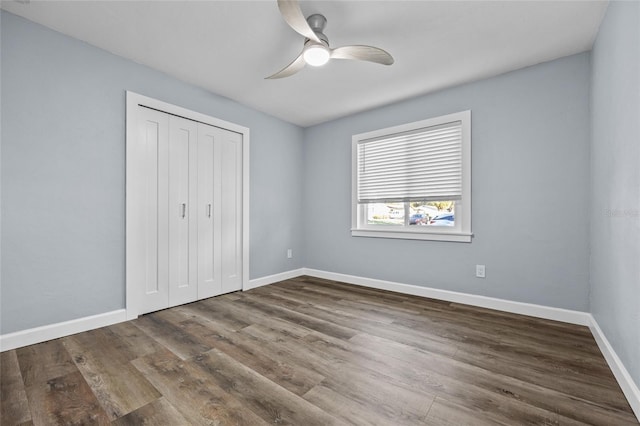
(0, 309, 128, 352)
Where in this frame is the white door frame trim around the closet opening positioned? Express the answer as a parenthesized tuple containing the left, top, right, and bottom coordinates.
(125, 90, 250, 320)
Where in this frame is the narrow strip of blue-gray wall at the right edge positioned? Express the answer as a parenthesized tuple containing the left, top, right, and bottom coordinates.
(590, 2, 640, 386)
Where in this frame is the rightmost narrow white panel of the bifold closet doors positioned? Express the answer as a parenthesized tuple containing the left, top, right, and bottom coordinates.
(220, 130, 242, 293)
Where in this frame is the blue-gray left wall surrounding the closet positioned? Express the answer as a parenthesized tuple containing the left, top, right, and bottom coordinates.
(0, 12, 303, 334)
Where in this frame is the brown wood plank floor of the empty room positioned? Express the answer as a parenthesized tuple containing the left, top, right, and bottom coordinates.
(0, 277, 638, 426)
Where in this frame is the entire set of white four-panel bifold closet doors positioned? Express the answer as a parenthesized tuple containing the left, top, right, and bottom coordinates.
(134, 106, 242, 313)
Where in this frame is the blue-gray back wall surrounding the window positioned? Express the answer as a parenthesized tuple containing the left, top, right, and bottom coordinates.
(304, 53, 589, 311)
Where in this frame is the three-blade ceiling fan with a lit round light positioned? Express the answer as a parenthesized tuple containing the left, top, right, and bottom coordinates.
(267, 0, 393, 79)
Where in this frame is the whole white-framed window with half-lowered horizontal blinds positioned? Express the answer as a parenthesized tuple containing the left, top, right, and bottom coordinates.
(351, 111, 472, 242)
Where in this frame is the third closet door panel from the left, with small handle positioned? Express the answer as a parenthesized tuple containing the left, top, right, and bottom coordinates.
(197, 123, 222, 299)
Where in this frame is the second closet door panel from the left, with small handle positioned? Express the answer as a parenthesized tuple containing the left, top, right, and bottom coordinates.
(168, 116, 198, 306)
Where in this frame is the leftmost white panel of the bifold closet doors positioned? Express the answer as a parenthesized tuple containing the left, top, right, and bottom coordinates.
(136, 107, 169, 313)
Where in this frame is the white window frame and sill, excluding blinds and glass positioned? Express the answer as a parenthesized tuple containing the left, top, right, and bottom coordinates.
(351, 110, 473, 243)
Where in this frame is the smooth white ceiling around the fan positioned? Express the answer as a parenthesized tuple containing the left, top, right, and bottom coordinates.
(2, 0, 607, 127)
